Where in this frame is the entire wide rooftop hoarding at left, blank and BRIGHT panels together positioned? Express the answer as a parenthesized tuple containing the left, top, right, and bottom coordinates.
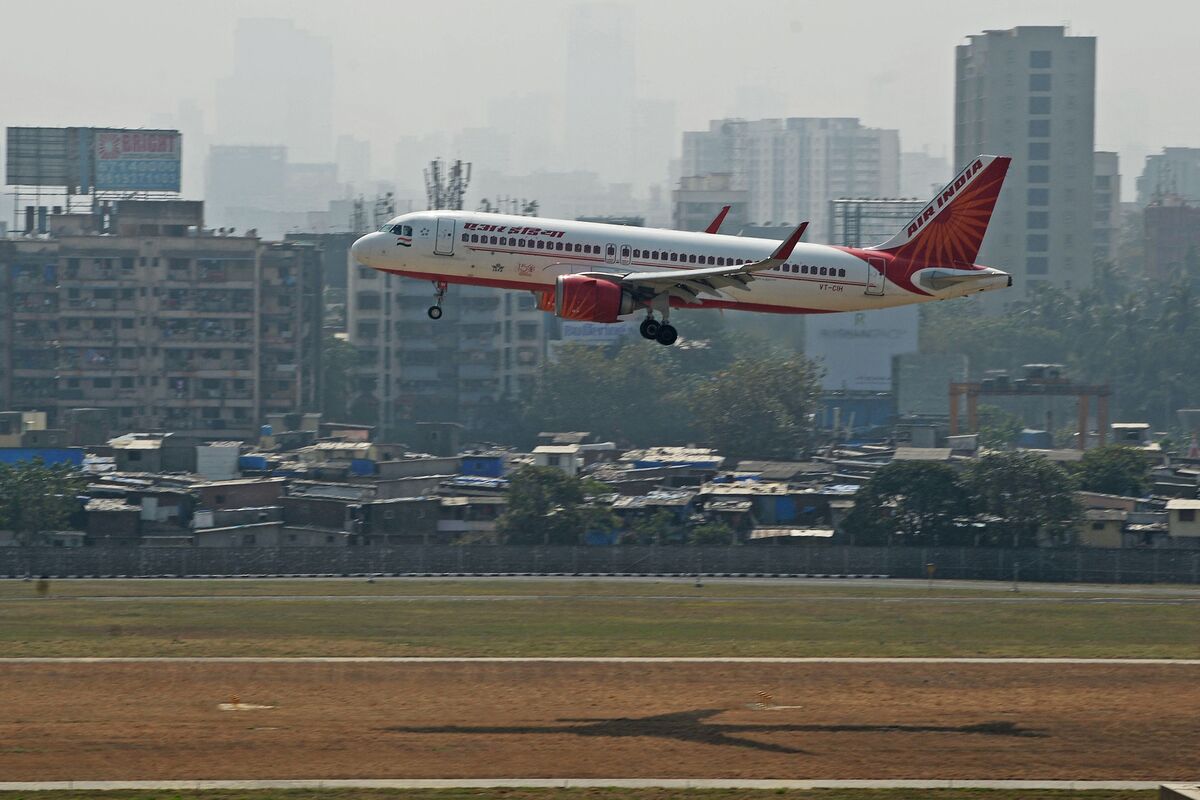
(5, 127, 181, 194)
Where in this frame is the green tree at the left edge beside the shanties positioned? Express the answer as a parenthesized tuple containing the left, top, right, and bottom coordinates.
(0, 458, 86, 546)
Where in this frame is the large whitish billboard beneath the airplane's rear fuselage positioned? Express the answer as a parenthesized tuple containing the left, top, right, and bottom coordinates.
(804, 306, 918, 392)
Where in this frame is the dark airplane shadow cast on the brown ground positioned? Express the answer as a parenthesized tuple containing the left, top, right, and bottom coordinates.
(384, 709, 1046, 754)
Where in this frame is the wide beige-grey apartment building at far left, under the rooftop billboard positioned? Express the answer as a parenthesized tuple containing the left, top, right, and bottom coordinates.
(0, 200, 322, 439)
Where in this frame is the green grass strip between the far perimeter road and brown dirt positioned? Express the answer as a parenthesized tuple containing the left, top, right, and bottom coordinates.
(0, 581, 1200, 658)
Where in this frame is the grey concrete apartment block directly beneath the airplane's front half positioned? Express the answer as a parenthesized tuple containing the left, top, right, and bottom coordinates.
(347, 265, 554, 434)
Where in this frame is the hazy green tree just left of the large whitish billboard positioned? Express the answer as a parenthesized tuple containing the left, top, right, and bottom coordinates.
(688, 355, 820, 458)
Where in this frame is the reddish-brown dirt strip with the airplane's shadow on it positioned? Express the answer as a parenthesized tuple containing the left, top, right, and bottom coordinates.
(0, 663, 1200, 781)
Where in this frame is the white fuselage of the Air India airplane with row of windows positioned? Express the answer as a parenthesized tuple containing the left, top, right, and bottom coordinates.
(353, 211, 1007, 313)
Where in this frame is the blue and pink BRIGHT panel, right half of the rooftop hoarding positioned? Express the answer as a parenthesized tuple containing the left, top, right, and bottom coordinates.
(91, 128, 181, 192)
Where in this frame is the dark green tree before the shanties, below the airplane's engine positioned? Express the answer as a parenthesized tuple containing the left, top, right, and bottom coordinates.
(496, 467, 616, 545)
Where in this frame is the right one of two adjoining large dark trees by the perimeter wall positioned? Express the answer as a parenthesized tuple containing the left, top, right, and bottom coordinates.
(962, 452, 1081, 547)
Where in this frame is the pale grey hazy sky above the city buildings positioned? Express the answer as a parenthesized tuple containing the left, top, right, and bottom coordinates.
(0, 0, 1200, 200)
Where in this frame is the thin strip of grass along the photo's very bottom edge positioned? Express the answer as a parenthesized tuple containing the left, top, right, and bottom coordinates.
(0, 789, 1157, 800)
